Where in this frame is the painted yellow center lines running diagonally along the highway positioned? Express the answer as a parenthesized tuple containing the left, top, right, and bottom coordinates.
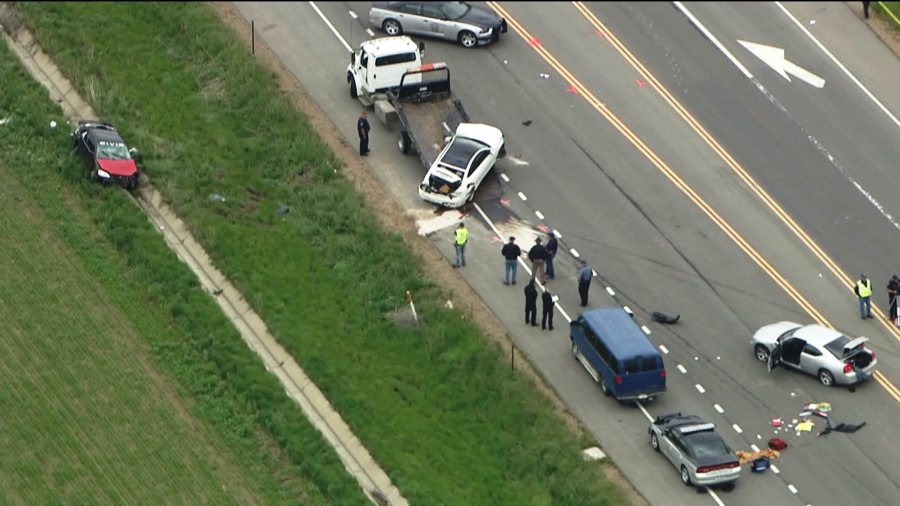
(487, 2, 900, 402)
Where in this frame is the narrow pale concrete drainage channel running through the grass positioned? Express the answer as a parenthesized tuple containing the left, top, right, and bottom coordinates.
(0, 2, 408, 506)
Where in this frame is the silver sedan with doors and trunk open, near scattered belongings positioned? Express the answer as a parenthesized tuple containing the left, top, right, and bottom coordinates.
(751, 321, 878, 387)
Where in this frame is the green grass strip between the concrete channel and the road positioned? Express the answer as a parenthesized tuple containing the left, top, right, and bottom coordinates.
(19, 3, 623, 505)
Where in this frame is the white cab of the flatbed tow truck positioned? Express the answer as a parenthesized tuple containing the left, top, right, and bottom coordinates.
(347, 36, 425, 106)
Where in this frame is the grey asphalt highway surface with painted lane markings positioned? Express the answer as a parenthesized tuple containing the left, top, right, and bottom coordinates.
(236, 2, 900, 505)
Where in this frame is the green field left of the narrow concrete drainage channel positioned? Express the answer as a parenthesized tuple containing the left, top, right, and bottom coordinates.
(0, 35, 365, 504)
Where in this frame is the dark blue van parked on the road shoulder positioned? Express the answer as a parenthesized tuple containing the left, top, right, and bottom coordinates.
(569, 307, 666, 401)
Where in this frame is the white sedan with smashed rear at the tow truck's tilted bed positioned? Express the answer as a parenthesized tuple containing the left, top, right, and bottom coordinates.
(419, 123, 506, 208)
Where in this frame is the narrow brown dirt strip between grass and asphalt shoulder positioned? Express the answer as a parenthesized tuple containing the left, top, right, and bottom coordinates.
(211, 2, 648, 505)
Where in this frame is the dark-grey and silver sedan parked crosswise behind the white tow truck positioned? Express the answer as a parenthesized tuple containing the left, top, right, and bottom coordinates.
(369, 2, 507, 47)
